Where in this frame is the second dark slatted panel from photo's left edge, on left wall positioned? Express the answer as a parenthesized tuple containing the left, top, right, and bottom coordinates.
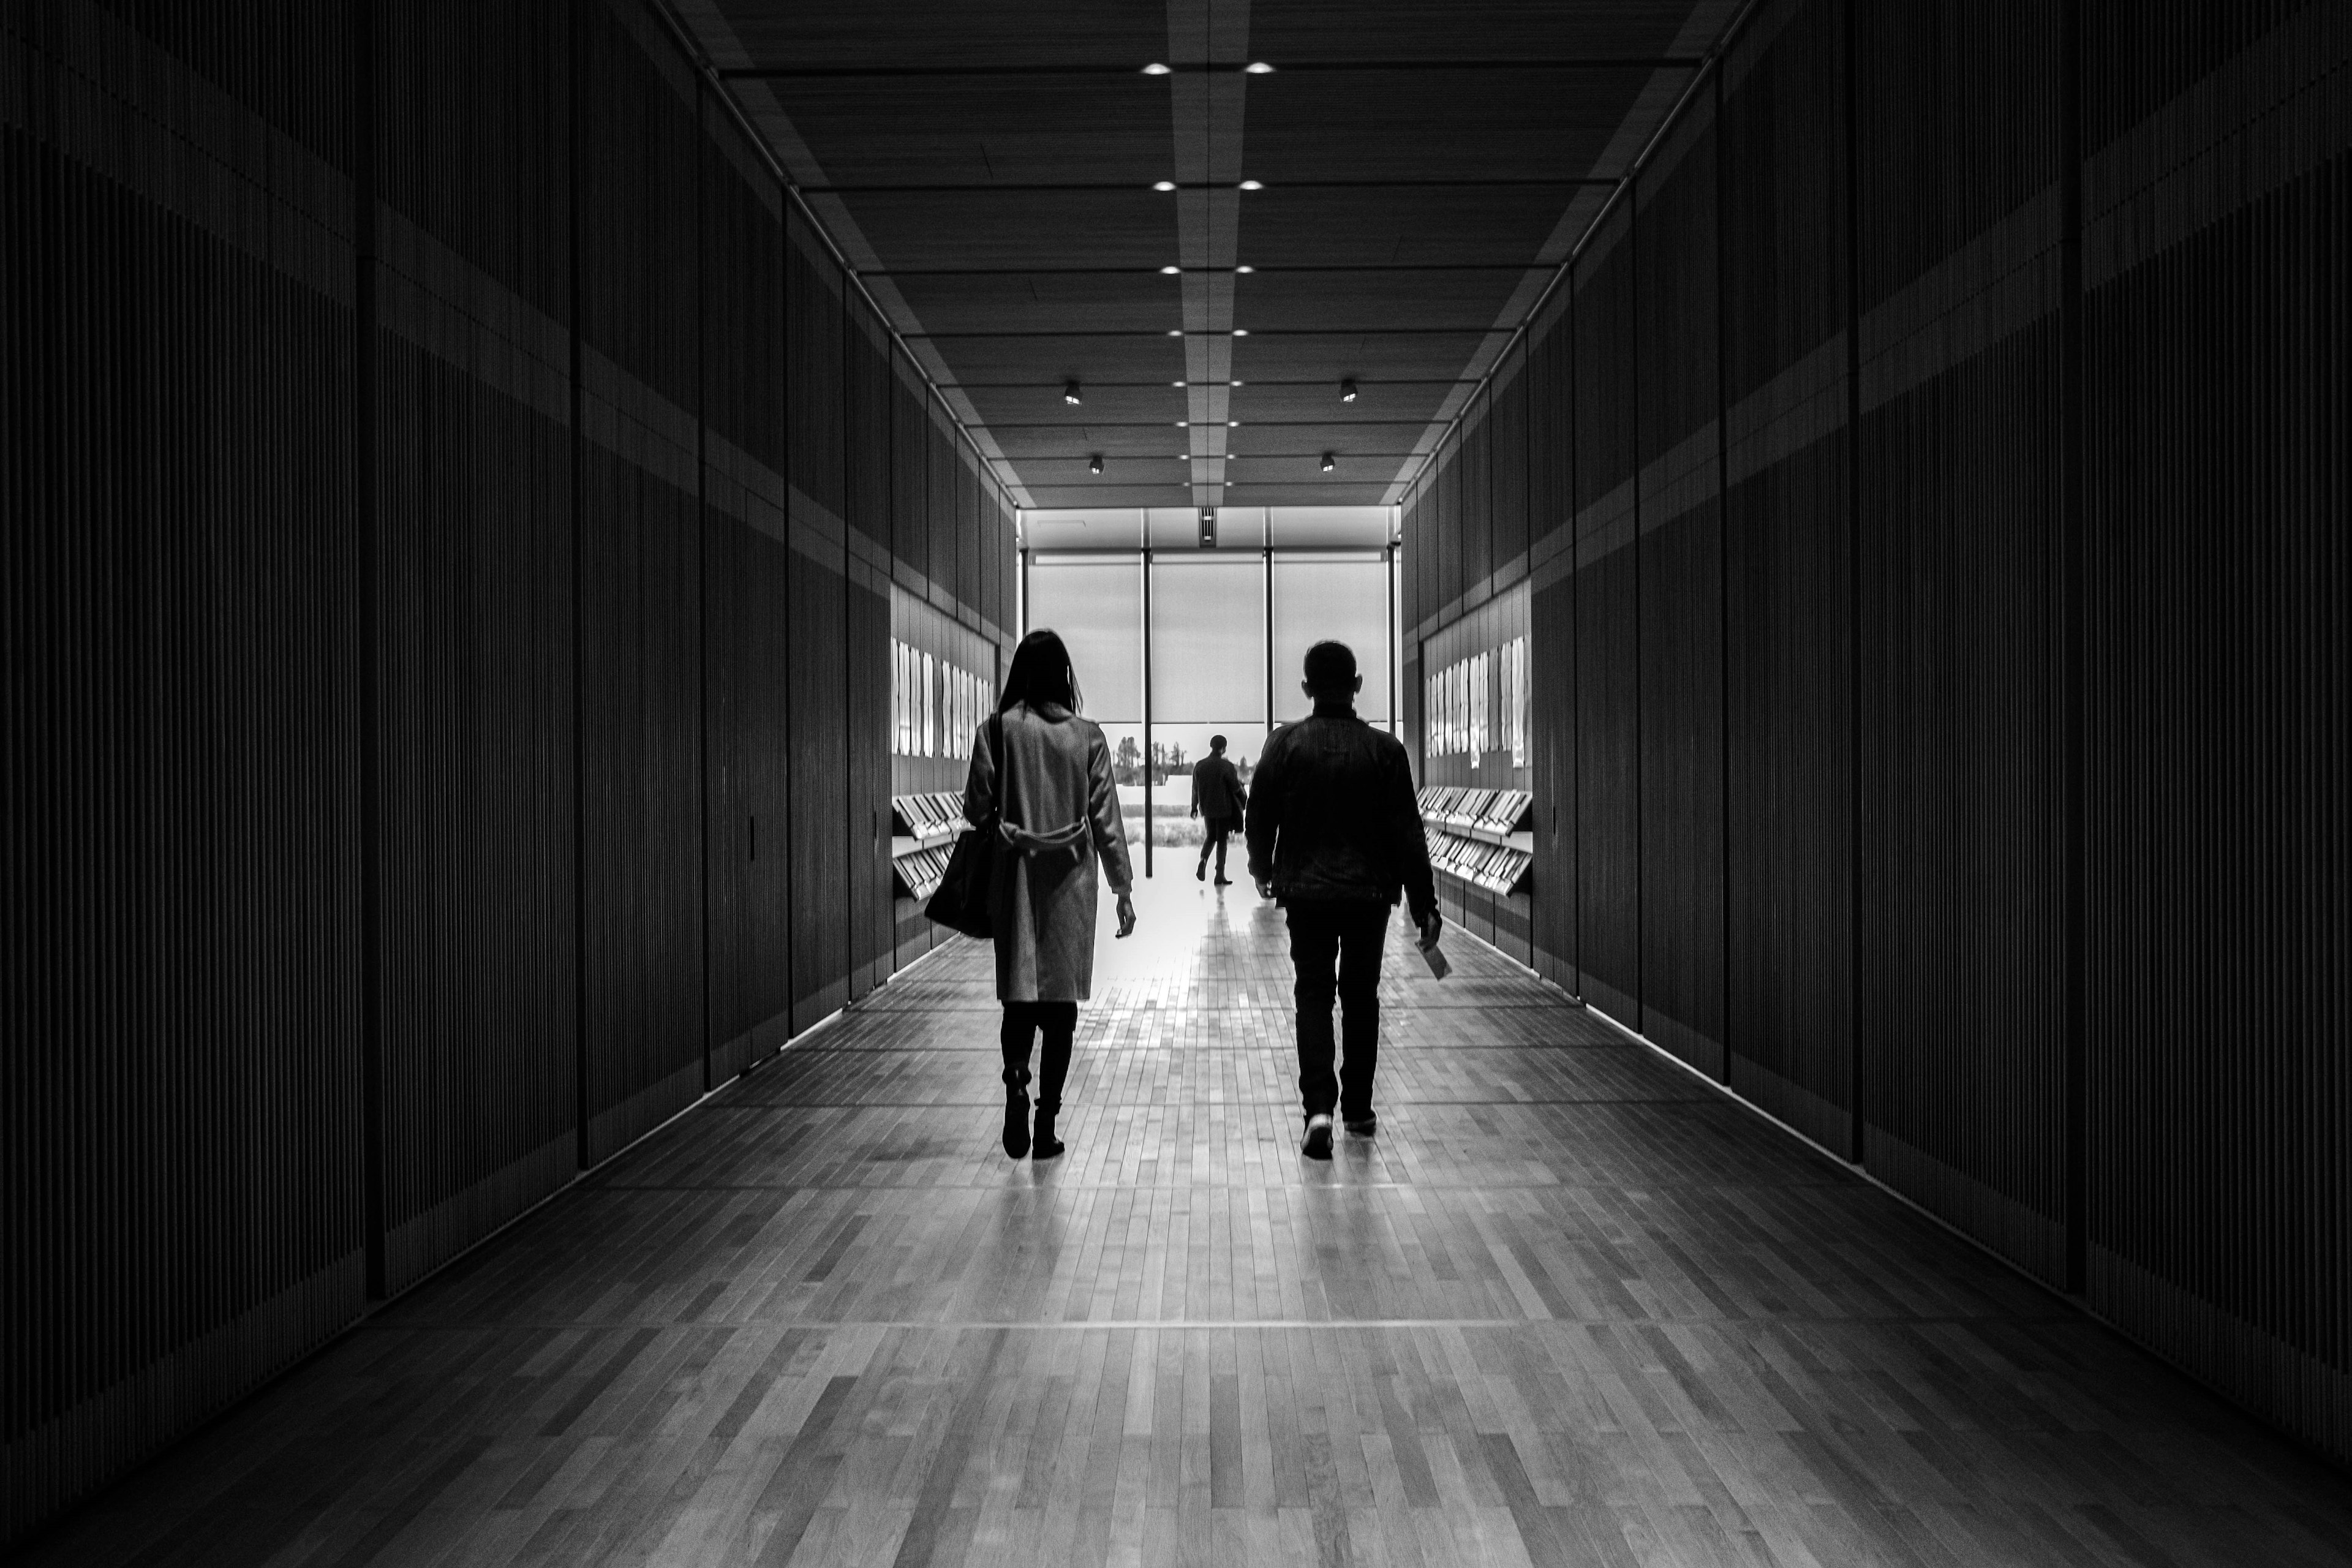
(376, 5, 581, 1293)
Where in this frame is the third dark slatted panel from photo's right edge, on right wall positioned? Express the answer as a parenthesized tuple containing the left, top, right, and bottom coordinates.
(1717, 0, 1853, 1152)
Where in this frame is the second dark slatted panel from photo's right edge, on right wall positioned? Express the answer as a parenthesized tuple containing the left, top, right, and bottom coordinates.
(1853, 0, 2067, 1286)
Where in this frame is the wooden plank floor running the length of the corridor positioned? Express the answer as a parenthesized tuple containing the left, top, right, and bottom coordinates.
(26, 879, 2352, 1568)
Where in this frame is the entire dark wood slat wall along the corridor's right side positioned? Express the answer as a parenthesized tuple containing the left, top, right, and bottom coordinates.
(1406, 0, 2352, 1462)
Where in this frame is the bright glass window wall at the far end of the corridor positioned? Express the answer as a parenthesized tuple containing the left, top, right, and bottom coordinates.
(1023, 508, 1397, 865)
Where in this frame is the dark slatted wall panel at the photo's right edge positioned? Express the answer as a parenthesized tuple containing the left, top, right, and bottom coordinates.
(2081, 0, 2352, 1462)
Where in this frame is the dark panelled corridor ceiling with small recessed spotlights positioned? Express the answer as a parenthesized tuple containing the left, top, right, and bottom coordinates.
(682, 0, 1731, 508)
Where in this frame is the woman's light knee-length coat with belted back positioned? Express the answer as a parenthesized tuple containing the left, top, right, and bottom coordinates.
(964, 703, 1134, 1001)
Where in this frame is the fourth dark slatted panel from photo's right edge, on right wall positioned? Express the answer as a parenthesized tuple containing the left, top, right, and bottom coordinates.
(1632, 99, 1724, 1079)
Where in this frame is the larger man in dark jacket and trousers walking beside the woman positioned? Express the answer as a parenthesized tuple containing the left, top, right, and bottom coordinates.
(1249, 642, 1442, 1159)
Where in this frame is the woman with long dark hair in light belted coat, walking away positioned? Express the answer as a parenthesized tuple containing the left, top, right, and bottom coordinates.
(964, 630, 1136, 1159)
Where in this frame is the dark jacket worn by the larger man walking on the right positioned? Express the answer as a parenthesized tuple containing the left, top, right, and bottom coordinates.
(1249, 710, 1437, 924)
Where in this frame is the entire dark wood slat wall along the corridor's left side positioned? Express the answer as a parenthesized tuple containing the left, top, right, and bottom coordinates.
(0, 0, 1009, 1542)
